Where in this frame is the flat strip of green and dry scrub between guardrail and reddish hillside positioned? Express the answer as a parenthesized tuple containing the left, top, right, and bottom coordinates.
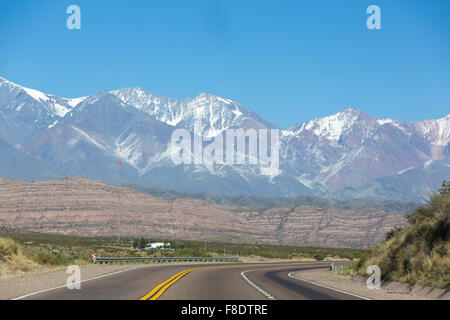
(0, 229, 363, 277)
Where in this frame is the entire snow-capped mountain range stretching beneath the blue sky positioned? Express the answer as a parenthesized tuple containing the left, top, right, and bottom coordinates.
(0, 78, 450, 201)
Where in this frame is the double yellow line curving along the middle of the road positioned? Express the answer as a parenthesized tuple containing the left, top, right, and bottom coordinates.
(140, 261, 338, 300)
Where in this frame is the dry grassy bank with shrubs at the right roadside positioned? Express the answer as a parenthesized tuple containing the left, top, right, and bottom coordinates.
(357, 182, 450, 288)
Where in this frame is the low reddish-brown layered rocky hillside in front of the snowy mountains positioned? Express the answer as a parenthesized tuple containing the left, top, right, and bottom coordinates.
(0, 177, 406, 248)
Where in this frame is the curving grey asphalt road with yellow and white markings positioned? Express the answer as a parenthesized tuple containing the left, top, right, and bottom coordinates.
(19, 262, 368, 300)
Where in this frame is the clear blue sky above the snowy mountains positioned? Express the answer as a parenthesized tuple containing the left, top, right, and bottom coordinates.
(0, 0, 450, 127)
